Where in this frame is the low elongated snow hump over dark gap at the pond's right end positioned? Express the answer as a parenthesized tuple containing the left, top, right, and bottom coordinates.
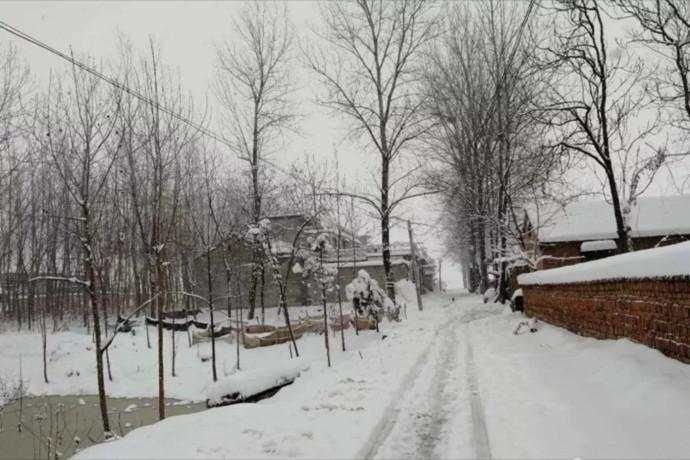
(204, 358, 309, 406)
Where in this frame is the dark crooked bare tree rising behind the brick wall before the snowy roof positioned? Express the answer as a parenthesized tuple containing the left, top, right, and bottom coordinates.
(545, 0, 669, 252)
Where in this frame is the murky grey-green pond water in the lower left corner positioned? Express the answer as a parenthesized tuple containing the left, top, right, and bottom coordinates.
(0, 395, 206, 459)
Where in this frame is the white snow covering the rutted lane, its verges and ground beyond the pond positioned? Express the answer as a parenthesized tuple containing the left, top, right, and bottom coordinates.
(0, 294, 690, 458)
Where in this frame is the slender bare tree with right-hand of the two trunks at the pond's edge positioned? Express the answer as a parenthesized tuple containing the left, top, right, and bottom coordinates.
(122, 41, 193, 419)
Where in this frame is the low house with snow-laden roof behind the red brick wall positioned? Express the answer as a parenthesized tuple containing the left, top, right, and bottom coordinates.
(523, 195, 690, 269)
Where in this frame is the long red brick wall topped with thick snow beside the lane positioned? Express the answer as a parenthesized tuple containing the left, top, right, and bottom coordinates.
(518, 242, 690, 363)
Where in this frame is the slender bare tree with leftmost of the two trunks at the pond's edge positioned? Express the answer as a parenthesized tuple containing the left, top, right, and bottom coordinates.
(37, 59, 121, 437)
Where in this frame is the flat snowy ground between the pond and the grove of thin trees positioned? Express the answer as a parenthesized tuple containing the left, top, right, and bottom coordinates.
(0, 309, 378, 402)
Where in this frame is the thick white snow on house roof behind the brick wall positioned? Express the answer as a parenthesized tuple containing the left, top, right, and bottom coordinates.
(533, 195, 690, 243)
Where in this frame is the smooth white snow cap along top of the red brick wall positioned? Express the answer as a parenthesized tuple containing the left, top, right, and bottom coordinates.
(518, 241, 690, 286)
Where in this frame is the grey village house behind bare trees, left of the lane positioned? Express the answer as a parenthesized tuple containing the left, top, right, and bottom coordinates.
(194, 214, 435, 308)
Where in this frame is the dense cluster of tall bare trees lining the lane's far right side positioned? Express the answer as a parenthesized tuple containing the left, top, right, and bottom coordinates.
(424, 0, 560, 294)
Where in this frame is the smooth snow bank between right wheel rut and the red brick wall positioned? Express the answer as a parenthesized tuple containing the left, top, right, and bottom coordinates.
(464, 304, 690, 458)
